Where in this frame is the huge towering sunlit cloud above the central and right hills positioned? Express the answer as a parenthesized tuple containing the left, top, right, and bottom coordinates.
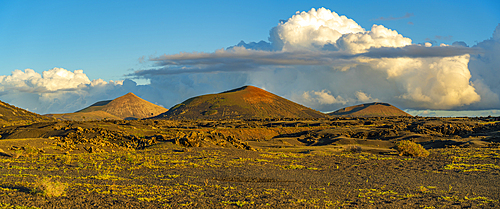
(134, 8, 488, 111)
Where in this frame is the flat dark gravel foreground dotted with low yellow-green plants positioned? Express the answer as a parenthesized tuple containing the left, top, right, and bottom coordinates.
(0, 143, 500, 208)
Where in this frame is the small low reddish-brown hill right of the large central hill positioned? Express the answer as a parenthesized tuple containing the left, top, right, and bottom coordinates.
(328, 102, 411, 117)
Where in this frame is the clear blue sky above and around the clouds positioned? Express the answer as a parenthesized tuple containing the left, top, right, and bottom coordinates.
(0, 0, 500, 116)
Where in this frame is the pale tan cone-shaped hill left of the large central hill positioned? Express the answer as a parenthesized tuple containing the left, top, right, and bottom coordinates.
(49, 93, 168, 120)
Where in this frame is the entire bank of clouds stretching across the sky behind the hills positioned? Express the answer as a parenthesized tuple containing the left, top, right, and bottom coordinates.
(0, 8, 500, 112)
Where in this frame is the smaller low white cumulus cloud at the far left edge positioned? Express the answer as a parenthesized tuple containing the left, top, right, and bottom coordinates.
(0, 68, 131, 113)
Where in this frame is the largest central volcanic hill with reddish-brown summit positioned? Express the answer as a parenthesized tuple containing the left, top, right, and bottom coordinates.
(153, 86, 328, 119)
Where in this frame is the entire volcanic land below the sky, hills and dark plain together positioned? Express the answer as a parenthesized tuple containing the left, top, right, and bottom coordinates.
(0, 87, 500, 208)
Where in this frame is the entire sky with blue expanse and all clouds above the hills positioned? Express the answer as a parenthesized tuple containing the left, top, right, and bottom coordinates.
(0, 0, 500, 116)
